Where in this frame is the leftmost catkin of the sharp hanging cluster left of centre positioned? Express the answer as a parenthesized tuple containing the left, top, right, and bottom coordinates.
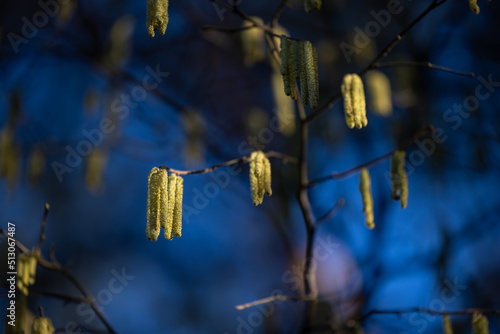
(146, 167, 161, 241)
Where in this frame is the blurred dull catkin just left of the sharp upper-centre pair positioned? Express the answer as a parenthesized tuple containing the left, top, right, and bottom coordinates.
(241, 16, 266, 67)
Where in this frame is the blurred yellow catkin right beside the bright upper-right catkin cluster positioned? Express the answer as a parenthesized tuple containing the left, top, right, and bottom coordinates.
(365, 71, 392, 117)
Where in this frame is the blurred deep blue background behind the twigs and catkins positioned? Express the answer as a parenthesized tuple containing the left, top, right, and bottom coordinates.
(0, 0, 500, 334)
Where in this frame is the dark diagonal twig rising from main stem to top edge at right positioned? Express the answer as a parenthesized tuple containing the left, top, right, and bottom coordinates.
(306, 0, 447, 123)
